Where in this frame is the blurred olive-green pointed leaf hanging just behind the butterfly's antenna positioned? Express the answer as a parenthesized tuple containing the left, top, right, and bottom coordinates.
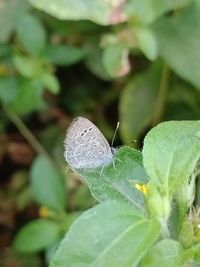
(119, 65, 161, 143)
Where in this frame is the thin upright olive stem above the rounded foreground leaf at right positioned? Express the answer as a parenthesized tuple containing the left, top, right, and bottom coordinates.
(152, 64, 170, 126)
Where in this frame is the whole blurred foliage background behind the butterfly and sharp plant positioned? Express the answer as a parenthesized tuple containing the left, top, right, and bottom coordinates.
(0, 0, 200, 267)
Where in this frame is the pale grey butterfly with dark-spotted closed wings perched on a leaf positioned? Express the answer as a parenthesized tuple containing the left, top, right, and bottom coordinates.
(64, 117, 116, 169)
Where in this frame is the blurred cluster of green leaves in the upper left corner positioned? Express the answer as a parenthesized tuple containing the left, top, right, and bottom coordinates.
(0, 0, 84, 116)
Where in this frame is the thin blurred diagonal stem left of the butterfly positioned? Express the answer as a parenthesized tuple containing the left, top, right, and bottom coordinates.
(3, 106, 53, 162)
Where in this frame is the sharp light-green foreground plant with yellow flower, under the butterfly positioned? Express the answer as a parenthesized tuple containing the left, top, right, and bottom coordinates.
(50, 121, 200, 267)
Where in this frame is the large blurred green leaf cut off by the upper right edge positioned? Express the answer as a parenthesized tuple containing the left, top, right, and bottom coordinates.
(153, 4, 200, 88)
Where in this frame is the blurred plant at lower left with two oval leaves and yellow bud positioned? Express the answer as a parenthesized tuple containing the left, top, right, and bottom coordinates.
(13, 156, 69, 258)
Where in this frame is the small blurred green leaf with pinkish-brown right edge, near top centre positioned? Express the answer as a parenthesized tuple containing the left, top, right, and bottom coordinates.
(103, 43, 130, 77)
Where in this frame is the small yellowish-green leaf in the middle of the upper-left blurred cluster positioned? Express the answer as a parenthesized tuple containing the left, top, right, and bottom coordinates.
(13, 55, 43, 78)
